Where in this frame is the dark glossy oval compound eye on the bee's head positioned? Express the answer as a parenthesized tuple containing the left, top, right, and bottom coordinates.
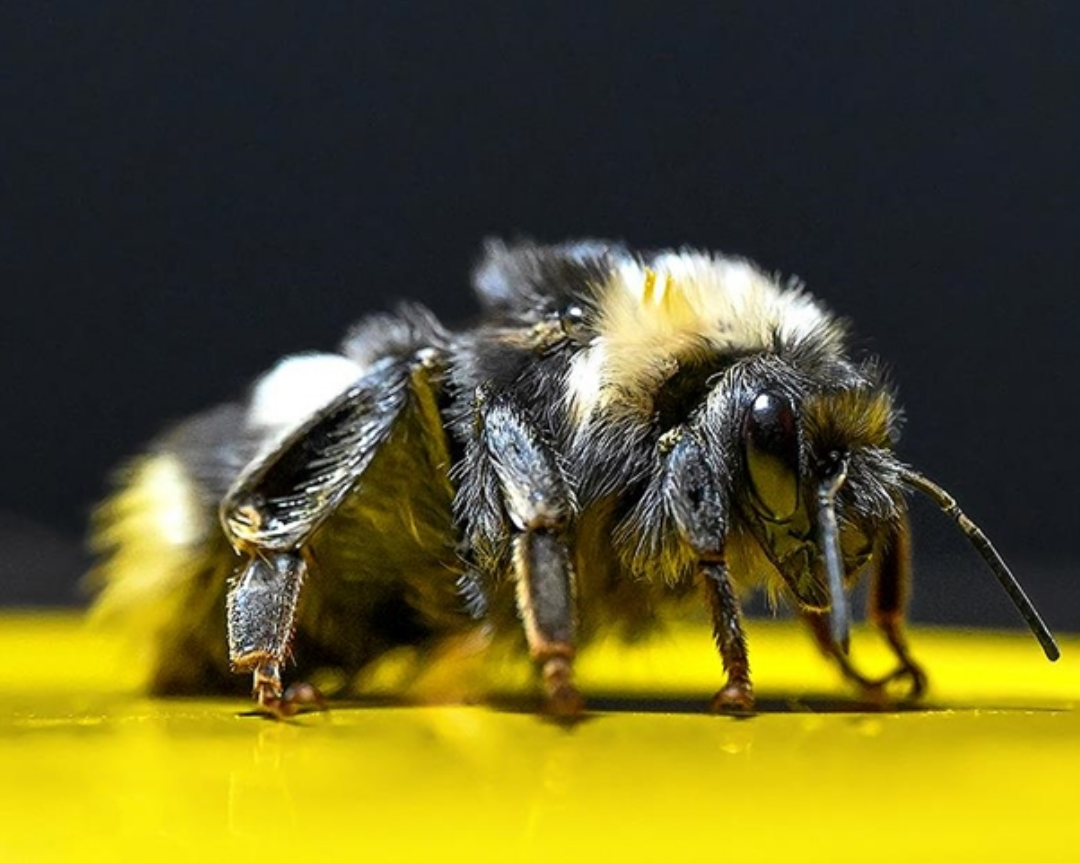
(743, 392, 799, 522)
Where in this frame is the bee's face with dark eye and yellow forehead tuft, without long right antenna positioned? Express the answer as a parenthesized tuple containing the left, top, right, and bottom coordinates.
(740, 378, 903, 640)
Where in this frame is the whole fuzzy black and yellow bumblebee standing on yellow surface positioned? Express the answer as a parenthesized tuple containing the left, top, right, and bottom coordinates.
(88, 241, 1058, 714)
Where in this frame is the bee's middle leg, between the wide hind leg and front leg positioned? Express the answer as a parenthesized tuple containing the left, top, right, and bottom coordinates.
(484, 399, 584, 715)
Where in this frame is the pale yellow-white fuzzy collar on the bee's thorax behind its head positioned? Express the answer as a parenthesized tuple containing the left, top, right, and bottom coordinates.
(567, 252, 842, 424)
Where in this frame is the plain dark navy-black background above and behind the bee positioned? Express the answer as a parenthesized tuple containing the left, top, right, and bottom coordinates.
(0, 0, 1080, 630)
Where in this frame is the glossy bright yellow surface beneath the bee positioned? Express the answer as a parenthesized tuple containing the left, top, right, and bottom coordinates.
(0, 615, 1080, 863)
